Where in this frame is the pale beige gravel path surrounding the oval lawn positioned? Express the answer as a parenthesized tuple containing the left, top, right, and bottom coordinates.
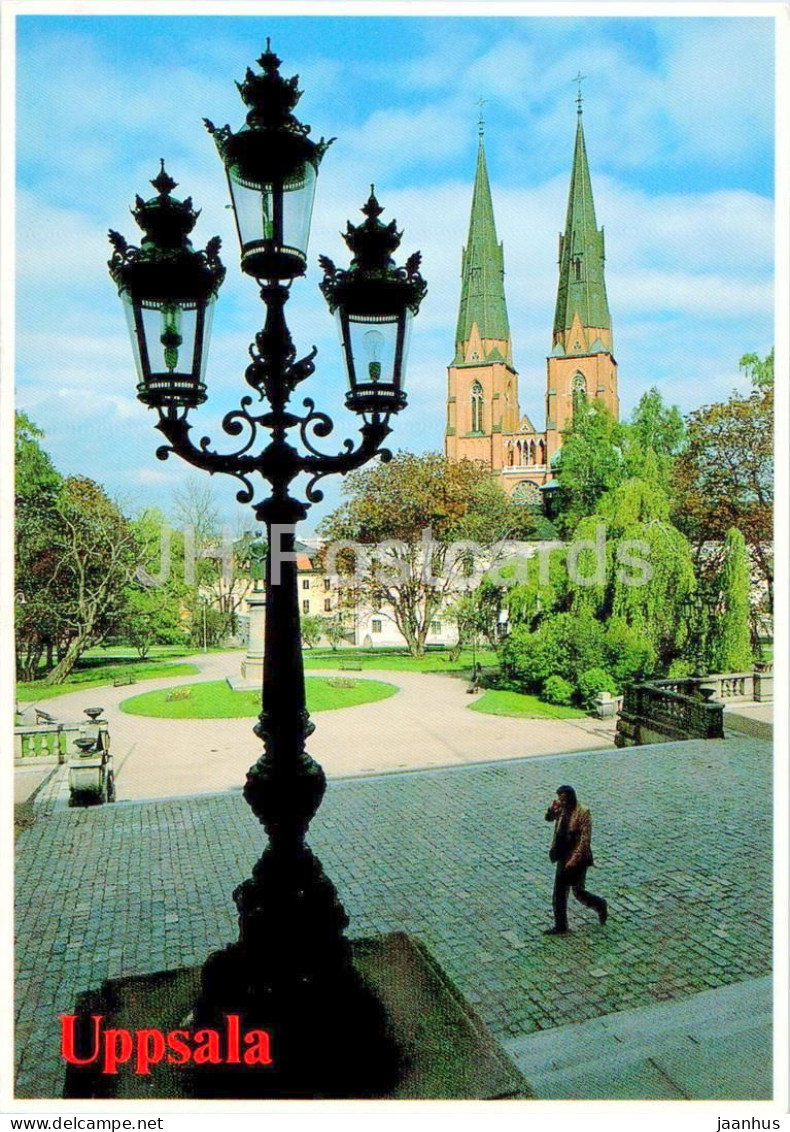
(21, 652, 615, 800)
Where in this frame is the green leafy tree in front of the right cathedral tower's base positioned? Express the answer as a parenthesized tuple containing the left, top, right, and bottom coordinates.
(556, 401, 626, 534)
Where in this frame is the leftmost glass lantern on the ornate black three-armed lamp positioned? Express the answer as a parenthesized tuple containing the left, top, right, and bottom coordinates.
(109, 161, 225, 414)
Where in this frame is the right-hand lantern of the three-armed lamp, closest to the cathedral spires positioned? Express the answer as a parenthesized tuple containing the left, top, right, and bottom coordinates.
(320, 185, 427, 419)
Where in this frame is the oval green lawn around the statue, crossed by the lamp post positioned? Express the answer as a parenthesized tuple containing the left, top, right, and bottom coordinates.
(120, 676, 397, 719)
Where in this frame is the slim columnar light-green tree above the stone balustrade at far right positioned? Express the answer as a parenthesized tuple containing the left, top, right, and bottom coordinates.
(709, 528, 754, 672)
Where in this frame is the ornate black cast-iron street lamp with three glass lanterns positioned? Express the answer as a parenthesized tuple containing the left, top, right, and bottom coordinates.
(110, 41, 426, 1097)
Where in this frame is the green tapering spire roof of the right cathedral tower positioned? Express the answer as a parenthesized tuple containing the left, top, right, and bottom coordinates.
(555, 109, 611, 336)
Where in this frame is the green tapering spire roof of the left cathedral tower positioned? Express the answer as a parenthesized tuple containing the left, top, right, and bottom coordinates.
(455, 130, 510, 357)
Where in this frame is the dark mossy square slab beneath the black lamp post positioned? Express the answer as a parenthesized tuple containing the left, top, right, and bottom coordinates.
(63, 932, 533, 1100)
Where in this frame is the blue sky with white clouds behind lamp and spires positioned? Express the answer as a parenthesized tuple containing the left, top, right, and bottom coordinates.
(16, 5, 774, 530)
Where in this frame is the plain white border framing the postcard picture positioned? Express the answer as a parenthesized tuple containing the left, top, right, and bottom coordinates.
(0, 0, 790, 1132)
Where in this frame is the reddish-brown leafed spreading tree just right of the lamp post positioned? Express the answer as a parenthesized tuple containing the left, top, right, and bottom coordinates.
(319, 453, 532, 657)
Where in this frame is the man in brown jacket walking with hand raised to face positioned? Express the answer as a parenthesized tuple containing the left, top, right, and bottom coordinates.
(543, 786, 609, 935)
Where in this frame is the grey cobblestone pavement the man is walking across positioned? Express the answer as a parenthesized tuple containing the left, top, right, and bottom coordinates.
(17, 733, 772, 1097)
